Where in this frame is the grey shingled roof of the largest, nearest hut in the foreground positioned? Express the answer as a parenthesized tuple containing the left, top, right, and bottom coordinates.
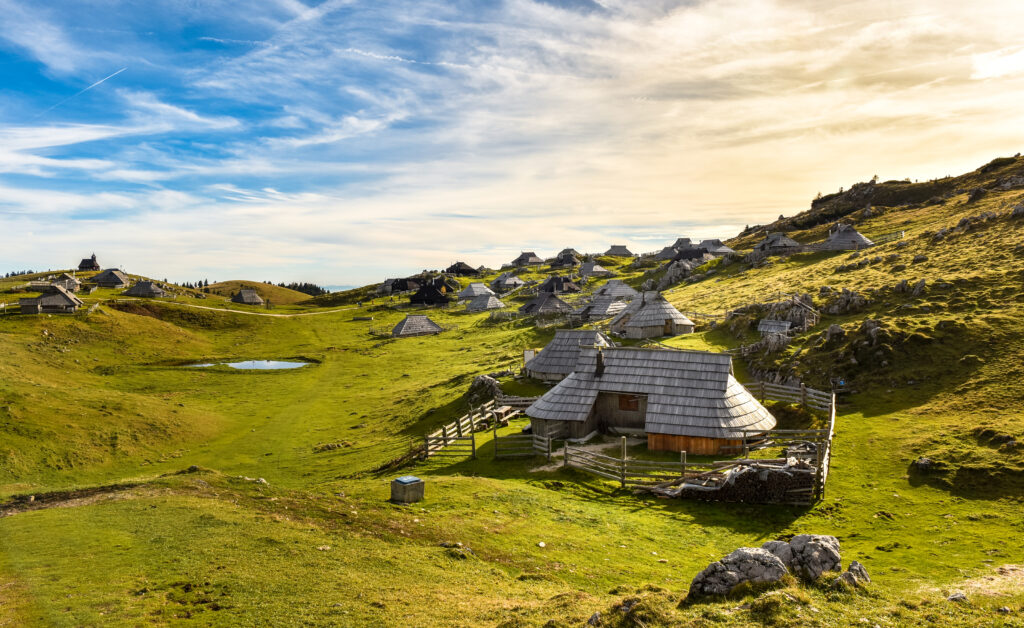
(526, 347, 775, 438)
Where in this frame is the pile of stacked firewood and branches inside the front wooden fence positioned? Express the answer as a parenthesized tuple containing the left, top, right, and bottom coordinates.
(637, 457, 816, 504)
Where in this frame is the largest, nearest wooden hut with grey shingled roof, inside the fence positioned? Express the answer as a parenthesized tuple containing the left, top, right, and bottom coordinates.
(526, 346, 775, 456)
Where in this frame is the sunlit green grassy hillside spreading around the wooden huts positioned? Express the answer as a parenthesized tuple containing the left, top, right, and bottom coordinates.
(0, 159, 1024, 627)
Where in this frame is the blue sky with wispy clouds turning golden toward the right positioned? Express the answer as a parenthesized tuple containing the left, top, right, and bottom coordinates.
(0, 0, 1024, 285)
